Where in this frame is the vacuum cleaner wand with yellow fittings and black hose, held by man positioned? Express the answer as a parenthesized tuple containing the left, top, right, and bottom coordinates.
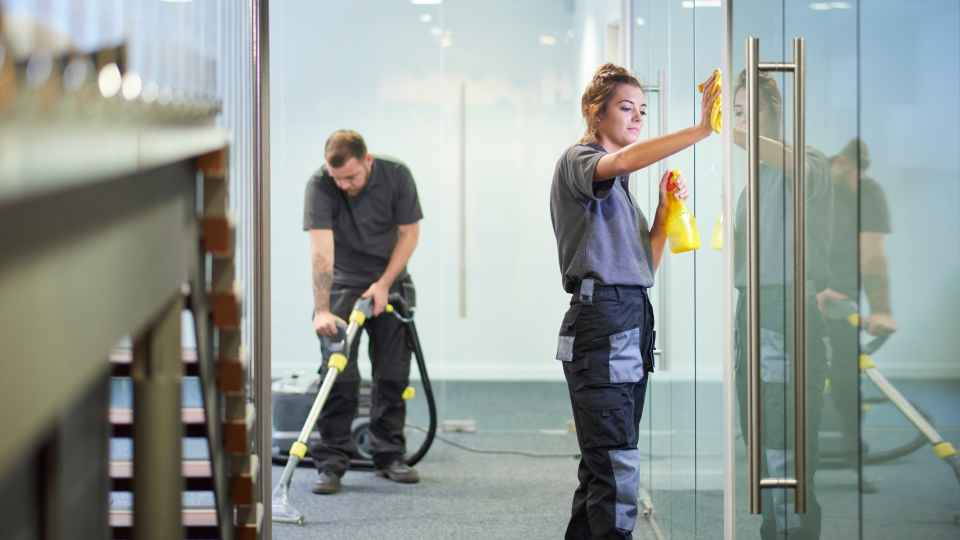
(271, 293, 437, 525)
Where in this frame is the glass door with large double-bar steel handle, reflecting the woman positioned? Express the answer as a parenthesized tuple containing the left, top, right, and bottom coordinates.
(725, 0, 860, 538)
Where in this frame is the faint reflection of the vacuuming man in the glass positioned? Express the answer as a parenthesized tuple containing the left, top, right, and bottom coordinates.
(818, 139, 897, 480)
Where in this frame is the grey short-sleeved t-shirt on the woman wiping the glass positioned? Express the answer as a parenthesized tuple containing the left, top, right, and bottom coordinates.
(550, 144, 653, 293)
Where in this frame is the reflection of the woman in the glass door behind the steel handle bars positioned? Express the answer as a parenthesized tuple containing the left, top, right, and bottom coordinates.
(733, 72, 833, 540)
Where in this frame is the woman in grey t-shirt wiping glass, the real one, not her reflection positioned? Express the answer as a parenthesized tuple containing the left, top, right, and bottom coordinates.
(550, 64, 719, 539)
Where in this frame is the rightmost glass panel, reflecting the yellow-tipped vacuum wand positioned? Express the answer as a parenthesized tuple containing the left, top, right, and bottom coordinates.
(860, 0, 960, 540)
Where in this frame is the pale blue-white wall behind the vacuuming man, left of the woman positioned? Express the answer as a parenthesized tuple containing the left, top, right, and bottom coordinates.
(270, 0, 580, 380)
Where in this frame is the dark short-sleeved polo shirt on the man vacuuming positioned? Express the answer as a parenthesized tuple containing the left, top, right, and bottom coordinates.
(303, 156, 423, 289)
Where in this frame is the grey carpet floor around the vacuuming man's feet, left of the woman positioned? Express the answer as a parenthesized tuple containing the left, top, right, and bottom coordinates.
(273, 430, 654, 540)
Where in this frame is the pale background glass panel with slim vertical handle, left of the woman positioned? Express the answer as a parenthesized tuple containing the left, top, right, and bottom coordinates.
(439, 0, 582, 384)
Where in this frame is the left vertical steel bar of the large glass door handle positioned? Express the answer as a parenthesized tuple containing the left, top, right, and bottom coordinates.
(746, 37, 761, 514)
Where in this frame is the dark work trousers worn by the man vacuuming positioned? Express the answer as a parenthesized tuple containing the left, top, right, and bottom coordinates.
(310, 279, 416, 476)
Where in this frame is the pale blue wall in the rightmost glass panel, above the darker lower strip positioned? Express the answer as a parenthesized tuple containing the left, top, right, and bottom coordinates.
(864, 0, 960, 378)
